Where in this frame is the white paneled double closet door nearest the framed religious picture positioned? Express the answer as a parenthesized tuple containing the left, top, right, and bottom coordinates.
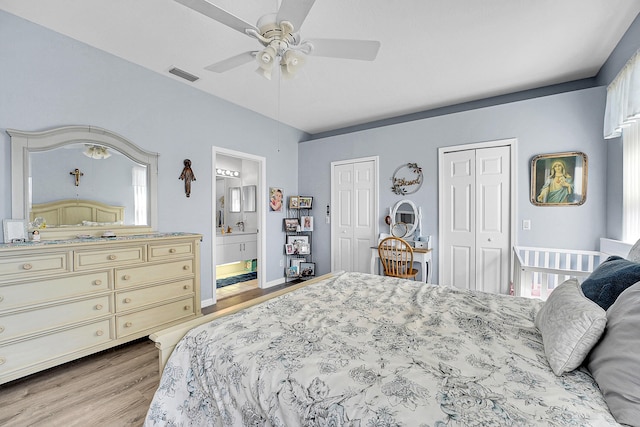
(440, 146, 511, 293)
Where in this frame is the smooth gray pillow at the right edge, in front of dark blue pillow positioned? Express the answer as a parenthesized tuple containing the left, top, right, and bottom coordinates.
(587, 282, 640, 425)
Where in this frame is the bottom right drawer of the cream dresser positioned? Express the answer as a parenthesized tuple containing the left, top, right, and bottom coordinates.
(116, 297, 195, 338)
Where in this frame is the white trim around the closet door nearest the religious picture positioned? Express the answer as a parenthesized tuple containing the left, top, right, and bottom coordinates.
(438, 138, 518, 291)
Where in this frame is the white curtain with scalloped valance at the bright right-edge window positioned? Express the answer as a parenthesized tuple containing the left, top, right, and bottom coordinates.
(604, 50, 640, 243)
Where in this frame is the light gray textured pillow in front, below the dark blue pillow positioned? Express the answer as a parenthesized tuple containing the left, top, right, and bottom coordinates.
(535, 279, 607, 375)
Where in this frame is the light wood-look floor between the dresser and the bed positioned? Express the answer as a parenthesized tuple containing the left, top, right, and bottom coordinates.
(0, 284, 290, 427)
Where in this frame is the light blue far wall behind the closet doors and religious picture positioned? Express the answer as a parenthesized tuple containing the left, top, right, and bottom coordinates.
(299, 87, 607, 277)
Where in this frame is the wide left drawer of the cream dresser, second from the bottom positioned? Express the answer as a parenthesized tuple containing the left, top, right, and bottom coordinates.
(0, 295, 113, 342)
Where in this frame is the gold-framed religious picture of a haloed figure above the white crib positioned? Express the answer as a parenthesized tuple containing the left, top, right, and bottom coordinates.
(531, 151, 588, 206)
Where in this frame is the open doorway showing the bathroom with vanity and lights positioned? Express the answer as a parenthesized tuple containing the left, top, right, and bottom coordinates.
(212, 147, 266, 304)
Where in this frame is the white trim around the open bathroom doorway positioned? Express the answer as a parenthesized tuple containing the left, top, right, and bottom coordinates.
(211, 146, 267, 304)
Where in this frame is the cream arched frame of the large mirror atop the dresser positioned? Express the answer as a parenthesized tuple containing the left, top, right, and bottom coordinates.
(7, 126, 158, 238)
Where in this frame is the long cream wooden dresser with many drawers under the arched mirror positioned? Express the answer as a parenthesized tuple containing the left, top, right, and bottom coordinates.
(0, 233, 202, 384)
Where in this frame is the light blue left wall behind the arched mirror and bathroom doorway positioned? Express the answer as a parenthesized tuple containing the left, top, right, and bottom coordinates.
(0, 11, 304, 300)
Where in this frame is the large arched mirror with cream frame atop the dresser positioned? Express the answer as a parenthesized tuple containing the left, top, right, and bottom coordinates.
(7, 126, 158, 239)
